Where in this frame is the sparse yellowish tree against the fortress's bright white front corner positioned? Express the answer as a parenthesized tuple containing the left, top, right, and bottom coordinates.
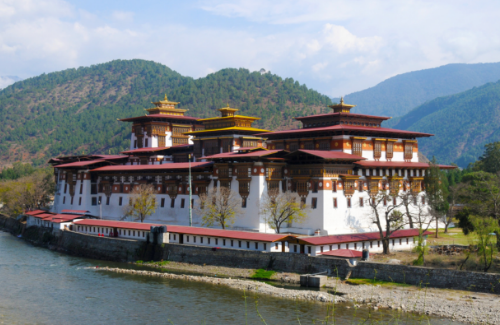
(260, 191, 309, 234)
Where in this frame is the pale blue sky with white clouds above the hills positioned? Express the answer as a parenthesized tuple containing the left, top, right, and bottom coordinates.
(0, 0, 500, 97)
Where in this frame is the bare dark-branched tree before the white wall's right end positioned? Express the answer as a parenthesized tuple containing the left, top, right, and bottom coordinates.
(367, 190, 405, 254)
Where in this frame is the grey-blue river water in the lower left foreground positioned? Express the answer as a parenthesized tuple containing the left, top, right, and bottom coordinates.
(0, 232, 458, 325)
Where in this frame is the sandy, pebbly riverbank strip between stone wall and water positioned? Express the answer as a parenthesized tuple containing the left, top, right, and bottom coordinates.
(95, 264, 500, 324)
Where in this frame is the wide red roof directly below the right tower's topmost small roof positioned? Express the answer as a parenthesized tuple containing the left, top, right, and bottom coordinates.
(255, 125, 433, 137)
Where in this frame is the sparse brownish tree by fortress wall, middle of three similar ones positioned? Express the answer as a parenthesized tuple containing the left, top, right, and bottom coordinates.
(196, 187, 241, 229)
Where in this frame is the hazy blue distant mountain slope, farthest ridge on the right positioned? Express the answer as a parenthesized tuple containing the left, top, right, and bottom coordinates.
(344, 63, 500, 117)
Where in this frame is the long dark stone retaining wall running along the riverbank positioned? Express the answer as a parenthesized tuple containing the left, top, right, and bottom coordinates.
(0, 215, 500, 294)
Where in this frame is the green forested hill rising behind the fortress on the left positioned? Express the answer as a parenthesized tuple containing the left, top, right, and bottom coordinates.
(0, 60, 331, 166)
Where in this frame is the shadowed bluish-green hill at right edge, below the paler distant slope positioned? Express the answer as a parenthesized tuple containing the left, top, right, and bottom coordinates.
(393, 81, 500, 167)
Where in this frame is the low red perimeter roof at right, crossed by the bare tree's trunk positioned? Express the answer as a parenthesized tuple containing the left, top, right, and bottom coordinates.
(299, 229, 431, 245)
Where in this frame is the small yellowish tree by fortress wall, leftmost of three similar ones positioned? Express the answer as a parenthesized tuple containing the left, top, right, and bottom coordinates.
(122, 184, 156, 222)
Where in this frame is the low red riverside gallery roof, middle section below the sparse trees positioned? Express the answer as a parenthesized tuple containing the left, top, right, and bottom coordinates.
(167, 225, 289, 242)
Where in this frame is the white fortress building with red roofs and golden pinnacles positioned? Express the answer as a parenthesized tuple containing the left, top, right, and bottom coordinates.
(50, 96, 454, 235)
